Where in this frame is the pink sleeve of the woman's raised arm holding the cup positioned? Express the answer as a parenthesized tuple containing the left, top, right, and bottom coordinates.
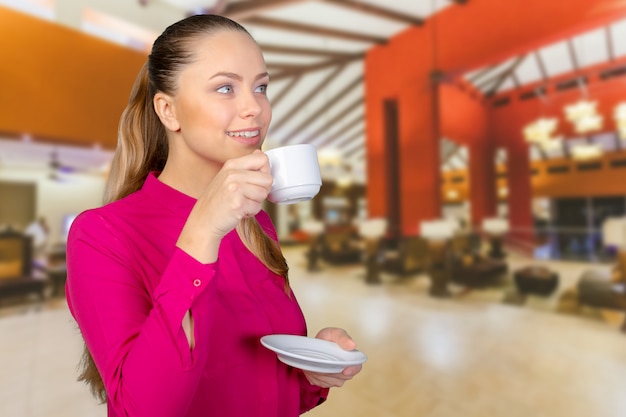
(67, 211, 219, 417)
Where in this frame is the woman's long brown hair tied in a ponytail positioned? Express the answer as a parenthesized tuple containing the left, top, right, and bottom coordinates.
(78, 15, 290, 402)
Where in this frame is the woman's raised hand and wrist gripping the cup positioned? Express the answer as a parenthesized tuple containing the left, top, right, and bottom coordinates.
(176, 150, 273, 263)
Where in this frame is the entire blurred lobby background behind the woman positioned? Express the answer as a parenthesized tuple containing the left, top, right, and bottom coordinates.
(0, 0, 626, 417)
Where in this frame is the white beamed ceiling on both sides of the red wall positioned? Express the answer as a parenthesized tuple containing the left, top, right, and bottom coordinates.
(0, 0, 626, 181)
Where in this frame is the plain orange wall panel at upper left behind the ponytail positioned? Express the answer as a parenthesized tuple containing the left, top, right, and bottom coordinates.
(0, 6, 146, 148)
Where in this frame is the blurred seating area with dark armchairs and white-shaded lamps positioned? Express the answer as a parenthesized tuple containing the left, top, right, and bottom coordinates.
(286, 210, 626, 331)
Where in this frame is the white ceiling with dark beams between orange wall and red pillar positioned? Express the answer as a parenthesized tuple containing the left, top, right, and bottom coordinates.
(0, 0, 466, 181)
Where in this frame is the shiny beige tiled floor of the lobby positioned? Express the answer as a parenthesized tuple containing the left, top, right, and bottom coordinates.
(0, 248, 626, 417)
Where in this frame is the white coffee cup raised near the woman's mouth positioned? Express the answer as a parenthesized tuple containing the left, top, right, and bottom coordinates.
(265, 143, 322, 204)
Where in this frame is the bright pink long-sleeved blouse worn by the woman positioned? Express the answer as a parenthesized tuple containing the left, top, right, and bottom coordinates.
(67, 174, 328, 417)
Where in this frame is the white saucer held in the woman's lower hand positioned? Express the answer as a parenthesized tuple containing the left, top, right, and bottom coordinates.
(261, 334, 367, 374)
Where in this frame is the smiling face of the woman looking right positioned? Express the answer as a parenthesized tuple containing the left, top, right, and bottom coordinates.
(170, 30, 272, 167)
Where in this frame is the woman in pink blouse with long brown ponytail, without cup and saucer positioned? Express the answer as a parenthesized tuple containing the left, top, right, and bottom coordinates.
(67, 15, 361, 417)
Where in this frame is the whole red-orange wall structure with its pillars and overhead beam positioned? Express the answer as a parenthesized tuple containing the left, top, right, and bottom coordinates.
(365, 0, 626, 234)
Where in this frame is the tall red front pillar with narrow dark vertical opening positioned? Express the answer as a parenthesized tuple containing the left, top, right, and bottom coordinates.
(365, 31, 440, 234)
